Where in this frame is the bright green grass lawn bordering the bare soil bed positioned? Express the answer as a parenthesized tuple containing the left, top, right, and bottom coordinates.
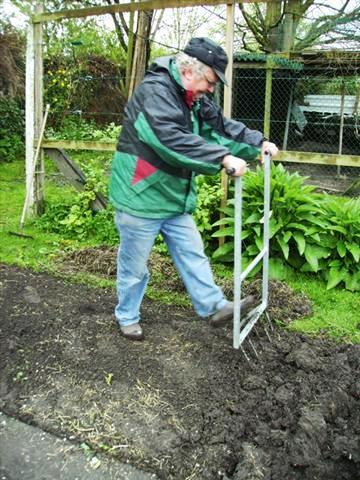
(0, 161, 360, 343)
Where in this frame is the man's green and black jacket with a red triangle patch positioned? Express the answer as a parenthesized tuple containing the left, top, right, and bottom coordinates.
(110, 57, 263, 218)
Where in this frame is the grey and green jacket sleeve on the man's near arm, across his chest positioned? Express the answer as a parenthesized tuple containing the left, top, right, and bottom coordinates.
(134, 84, 230, 174)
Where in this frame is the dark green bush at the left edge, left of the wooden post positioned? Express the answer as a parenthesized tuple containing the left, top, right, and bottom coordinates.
(0, 97, 25, 162)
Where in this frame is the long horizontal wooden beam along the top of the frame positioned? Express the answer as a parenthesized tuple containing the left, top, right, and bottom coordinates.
(32, 0, 267, 23)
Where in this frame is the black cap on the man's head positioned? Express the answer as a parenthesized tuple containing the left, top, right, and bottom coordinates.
(184, 37, 228, 85)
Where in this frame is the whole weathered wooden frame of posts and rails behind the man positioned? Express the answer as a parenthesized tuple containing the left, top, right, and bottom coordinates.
(26, 0, 360, 218)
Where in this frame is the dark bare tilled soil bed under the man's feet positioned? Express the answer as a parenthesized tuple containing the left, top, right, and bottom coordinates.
(0, 265, 360, 480)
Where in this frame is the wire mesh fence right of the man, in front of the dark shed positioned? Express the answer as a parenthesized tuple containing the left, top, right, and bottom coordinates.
(233, 55, 360, 191)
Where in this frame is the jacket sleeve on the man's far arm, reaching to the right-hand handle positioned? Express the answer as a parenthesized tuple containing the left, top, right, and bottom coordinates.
(200, 97, 264, 160)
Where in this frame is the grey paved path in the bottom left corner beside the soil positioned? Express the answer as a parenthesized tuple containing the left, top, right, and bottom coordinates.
(0, 412, 158, 480)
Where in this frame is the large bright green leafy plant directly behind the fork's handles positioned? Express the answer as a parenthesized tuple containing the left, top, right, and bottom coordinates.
(213, 165, 320, 261)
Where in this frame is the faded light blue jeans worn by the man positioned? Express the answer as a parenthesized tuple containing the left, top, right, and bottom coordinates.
(115, 211, 227, 326)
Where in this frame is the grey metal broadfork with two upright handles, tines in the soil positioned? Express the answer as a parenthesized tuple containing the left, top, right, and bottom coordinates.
(228, 152, 273, 361)
